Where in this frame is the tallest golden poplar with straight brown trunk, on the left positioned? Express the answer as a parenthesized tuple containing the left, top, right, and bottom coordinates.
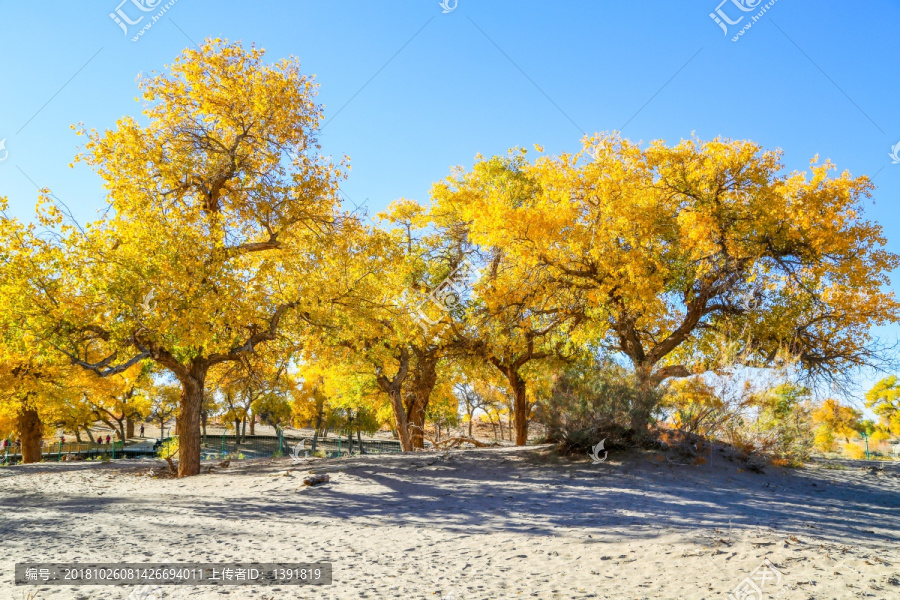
(20, 40, 346, 476)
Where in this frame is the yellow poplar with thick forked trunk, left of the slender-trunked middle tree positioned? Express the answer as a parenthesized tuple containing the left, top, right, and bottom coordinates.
(305, 200, 461, 451)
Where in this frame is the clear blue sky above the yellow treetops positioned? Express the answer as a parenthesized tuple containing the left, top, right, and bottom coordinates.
(0, 0, 900, 398)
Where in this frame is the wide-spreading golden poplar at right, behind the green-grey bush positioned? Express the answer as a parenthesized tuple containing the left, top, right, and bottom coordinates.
(448, 135, 900, 429)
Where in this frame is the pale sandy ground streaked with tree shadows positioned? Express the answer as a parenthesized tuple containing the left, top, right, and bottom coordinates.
(0, 449, 900, 600)
